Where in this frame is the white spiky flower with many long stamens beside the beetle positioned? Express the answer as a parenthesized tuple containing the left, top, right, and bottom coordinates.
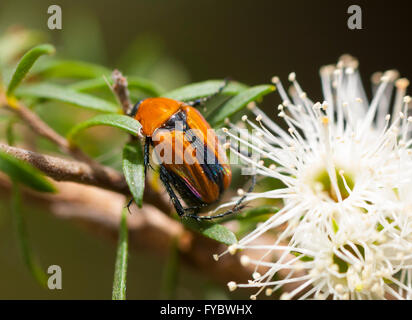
(220, 55, 412, 299)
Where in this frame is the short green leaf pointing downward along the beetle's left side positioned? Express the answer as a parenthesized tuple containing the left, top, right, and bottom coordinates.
(123, 141, 145, 208)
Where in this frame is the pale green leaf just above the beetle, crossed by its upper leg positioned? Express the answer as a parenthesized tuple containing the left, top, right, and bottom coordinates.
(164, 80, 247, 101)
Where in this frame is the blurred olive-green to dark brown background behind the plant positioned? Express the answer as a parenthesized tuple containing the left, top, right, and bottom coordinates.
(0, 0, 412, 299)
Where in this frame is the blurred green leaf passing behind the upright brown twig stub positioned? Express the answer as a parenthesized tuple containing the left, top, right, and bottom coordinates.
(69, 77, 163, 96)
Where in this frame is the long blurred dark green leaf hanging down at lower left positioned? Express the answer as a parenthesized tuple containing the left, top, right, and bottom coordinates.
(11, 182, 47, 287)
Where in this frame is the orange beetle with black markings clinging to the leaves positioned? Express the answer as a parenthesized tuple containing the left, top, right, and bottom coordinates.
(130, 84, 254, 220)
